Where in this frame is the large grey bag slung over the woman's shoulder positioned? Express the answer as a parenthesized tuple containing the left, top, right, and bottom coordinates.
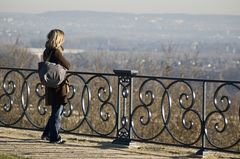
(38, 52, 67, 88)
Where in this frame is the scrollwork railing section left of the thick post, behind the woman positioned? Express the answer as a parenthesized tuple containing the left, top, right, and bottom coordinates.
(0, 68, 117, 136)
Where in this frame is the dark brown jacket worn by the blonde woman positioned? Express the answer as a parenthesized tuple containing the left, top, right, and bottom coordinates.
(43, 48, 70, 105)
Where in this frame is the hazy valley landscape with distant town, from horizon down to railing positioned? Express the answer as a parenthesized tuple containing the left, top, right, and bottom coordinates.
(0, 11, 240, 80)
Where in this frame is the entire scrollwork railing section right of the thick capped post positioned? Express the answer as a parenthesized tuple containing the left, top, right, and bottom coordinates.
(131, 76, 240, 152)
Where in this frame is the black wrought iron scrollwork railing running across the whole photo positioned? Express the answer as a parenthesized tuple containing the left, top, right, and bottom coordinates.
(0, 68, 240, 154)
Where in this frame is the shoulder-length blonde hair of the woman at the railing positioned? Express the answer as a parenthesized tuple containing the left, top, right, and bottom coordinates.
(45, 29, 64, 49)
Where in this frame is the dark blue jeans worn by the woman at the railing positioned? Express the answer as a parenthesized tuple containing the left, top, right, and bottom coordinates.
(43, 105, 63, 141)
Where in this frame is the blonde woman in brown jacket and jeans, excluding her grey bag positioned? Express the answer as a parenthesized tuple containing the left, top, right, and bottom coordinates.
(41, 29, 70, 143)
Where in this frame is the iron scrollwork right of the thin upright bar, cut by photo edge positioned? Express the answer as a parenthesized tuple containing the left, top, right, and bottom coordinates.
(205, 82, 240, 150)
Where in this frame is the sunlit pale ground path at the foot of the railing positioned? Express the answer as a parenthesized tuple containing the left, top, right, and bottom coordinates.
(0, 127, 240, 159)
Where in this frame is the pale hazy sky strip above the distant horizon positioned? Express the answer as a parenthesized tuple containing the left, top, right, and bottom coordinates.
(0, 0, 240, 15)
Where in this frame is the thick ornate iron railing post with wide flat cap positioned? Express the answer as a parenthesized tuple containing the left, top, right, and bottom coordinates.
(113, 70, 138, 145)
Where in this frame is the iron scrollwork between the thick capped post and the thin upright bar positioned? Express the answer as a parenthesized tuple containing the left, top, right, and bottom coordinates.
(132, 78, 201, 146)
